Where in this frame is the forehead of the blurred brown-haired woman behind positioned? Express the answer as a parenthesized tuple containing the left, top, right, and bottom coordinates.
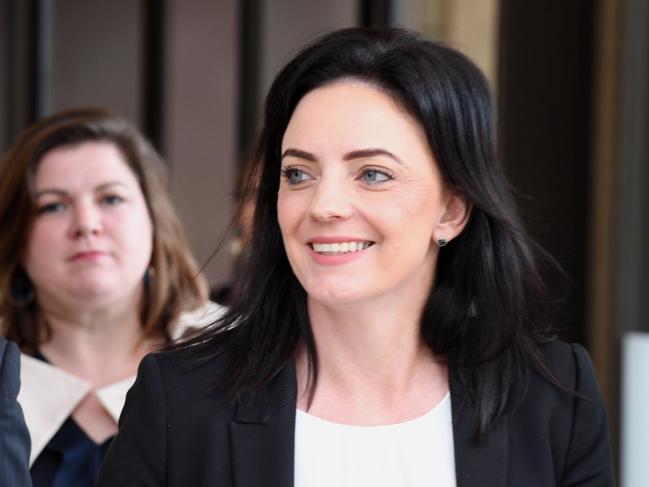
(34, 141, 137, 190)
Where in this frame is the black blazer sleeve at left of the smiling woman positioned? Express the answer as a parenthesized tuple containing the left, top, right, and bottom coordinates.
(97, 354, 167, 487)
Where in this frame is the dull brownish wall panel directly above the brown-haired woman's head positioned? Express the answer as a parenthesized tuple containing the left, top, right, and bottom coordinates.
(50, 0, 143, 124)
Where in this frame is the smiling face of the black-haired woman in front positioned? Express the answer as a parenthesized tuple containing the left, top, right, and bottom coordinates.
(278, 81, 449, 304)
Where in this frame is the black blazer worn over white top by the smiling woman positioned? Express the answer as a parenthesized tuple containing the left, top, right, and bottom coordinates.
(98, 341, 613, 487)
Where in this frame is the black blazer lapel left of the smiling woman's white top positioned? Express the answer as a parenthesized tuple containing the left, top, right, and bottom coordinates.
(230, 360, 297, 487)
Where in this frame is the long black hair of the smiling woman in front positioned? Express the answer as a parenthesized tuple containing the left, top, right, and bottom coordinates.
(185, 28, 545, 436)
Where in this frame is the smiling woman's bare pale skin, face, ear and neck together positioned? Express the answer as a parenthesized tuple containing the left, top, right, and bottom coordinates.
(278, 80, 470, 426)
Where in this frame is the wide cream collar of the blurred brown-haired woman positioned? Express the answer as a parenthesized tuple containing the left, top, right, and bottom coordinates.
(18, 301, 225, 467)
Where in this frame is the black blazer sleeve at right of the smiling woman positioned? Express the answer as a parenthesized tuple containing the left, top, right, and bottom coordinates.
(561, 344, 615, 487)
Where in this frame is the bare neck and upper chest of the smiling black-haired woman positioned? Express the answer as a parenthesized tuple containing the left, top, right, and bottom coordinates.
(297, 299, 448, 424)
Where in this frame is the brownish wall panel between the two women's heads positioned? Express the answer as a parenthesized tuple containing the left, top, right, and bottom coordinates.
(165, 0, 238, 284)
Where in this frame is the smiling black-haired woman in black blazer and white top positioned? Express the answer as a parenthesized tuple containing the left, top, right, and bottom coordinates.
(98, 29, 612, 487)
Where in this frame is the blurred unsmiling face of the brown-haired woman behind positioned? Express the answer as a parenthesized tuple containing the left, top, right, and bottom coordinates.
(23, 142, 153, 309)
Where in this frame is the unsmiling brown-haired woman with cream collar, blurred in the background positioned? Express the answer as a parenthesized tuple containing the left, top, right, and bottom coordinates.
(0, 109, 224, 486)
